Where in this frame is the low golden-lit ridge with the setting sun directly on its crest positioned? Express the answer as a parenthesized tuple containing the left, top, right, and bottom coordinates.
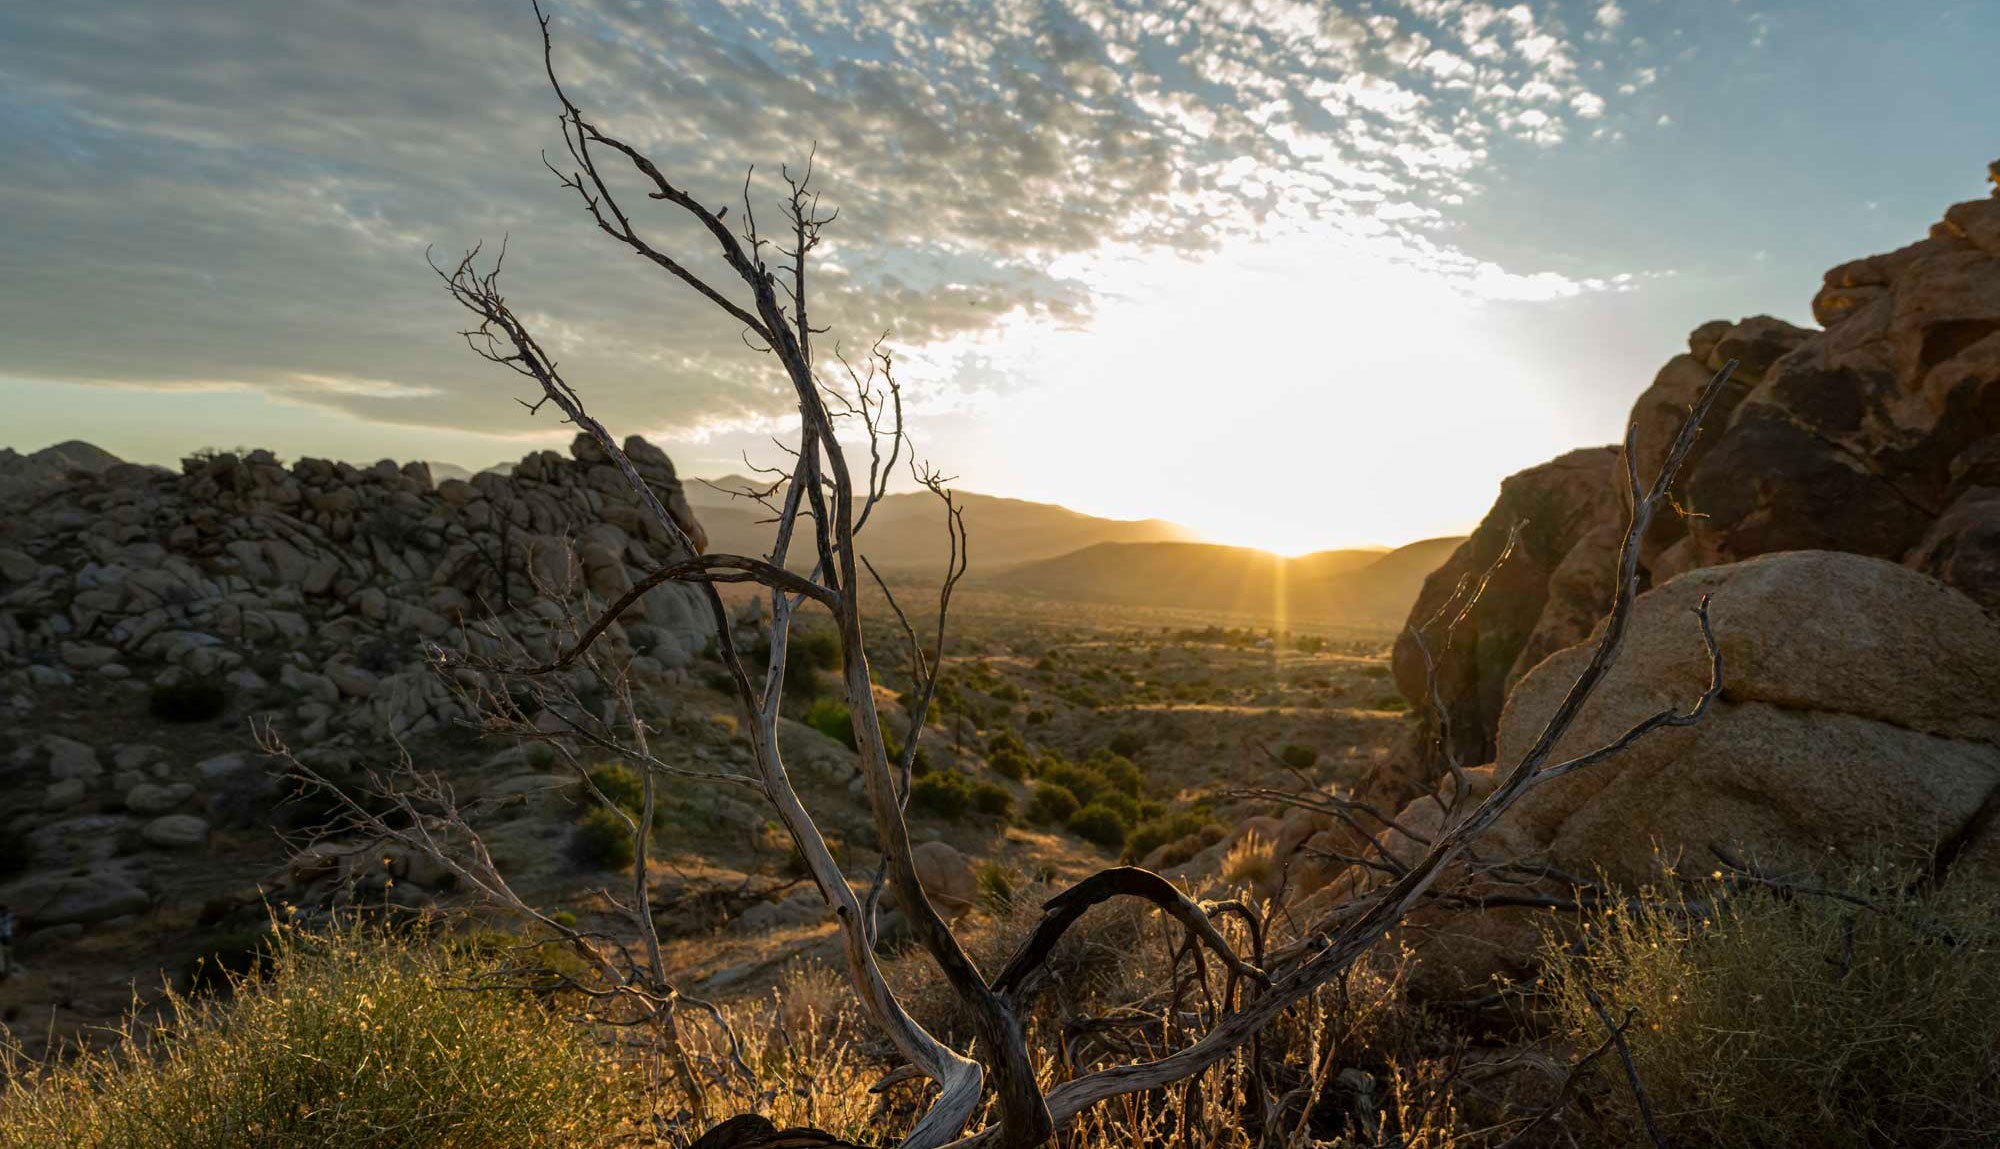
(986, 538, 1462, 623)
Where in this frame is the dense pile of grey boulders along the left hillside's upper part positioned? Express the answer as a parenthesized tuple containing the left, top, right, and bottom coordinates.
(0, 436, 710, 752)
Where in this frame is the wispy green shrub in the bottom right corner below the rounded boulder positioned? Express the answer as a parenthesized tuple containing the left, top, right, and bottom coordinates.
(1546, 871, 2000, 1149)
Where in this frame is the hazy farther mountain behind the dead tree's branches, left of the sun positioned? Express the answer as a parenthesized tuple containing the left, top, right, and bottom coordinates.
(686, 476, 1194, 575)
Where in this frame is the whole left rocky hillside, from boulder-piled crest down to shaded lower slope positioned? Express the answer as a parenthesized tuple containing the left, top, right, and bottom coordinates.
(0, 436, 708, 944)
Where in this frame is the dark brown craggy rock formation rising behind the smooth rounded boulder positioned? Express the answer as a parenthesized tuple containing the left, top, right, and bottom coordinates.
(1396, 171, 2000, 784)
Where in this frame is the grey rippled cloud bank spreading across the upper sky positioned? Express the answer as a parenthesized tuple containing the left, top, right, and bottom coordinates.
(0, 0, 1648, 434)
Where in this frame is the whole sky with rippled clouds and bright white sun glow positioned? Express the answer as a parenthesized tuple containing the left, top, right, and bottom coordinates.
(0, 0, 2000, 552)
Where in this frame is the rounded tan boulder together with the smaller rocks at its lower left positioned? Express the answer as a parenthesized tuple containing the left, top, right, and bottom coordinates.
(1280, 550, 2000, 997)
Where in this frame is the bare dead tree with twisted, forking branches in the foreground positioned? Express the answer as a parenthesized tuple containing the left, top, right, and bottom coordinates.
(304, 6, 1734, 1149)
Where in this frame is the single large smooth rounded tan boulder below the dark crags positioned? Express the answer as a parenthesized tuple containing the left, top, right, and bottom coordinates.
(1496, 550, 2000, 883)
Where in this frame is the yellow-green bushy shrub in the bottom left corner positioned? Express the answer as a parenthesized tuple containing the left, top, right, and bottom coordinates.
(0, 925, 616, 1149)
